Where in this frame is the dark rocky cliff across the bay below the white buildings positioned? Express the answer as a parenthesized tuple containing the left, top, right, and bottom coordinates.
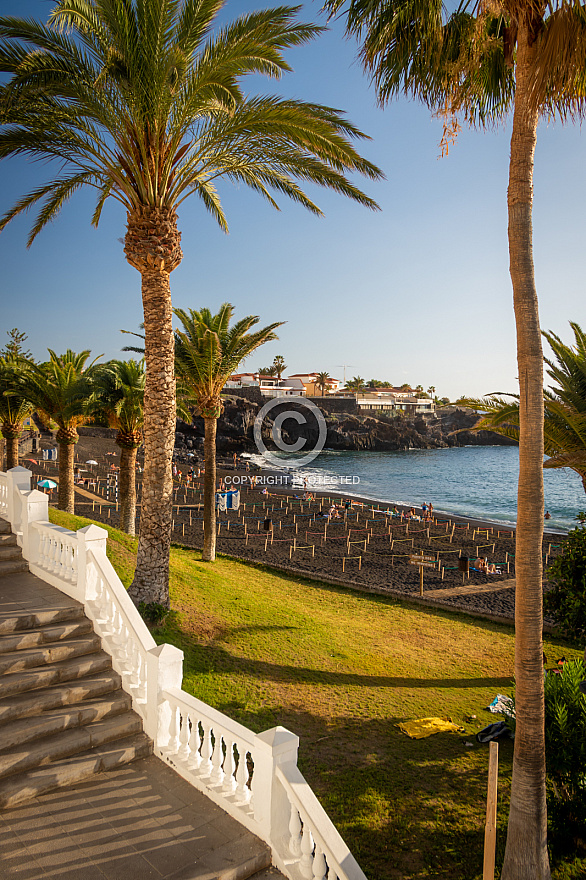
(177, 397, 514, 453)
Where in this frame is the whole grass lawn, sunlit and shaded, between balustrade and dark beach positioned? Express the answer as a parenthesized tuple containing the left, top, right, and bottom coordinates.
(51, 510, 580, 880)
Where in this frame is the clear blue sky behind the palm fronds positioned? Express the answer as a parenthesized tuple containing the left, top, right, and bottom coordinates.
(0, 0, 586, 398)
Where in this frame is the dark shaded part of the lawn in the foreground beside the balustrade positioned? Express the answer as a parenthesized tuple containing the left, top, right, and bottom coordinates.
(226, 704, 512, 880)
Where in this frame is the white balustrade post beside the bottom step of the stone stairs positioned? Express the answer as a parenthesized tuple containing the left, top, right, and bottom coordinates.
(144, 643, 183, 749)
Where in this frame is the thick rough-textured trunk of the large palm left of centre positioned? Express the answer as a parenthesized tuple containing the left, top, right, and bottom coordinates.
(125, 208, 183, 607)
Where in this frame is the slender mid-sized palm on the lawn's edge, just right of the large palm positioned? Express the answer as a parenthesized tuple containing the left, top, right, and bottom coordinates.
(175, 303, 281, 562)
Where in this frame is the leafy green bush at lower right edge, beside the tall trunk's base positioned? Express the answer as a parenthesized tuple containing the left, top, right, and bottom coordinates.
(544, 660, 586, 861)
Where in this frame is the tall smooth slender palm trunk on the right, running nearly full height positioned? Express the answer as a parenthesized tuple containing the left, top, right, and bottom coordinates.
(502, 25, 551, 880)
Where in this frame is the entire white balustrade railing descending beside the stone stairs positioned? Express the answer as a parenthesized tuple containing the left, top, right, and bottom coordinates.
(0, 468, 366, 880)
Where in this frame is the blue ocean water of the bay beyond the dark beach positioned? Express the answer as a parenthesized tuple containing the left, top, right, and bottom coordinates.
(252, 446, 586, 531)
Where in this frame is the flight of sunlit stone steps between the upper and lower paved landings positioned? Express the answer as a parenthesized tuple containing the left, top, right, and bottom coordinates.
(0, 562, 152, 809)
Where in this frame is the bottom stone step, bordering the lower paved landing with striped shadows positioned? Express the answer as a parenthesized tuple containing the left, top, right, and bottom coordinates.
(0, 733, 153, 809)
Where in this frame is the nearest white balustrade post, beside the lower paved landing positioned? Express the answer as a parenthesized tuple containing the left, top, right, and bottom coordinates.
(252, 727, 299, 845)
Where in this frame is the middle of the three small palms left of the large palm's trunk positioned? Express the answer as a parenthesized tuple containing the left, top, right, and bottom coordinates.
(23, 349, 98, 513)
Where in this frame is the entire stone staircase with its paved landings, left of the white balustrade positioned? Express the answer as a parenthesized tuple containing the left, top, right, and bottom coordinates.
(0, 519, 285, 880)
